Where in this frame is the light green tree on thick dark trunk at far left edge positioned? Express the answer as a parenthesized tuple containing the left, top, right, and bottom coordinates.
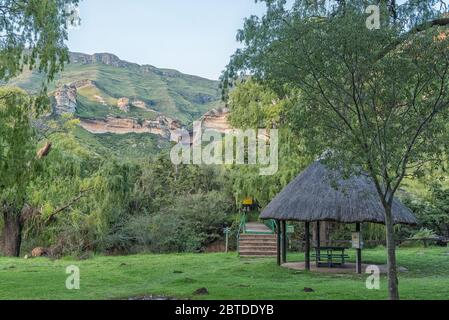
(0, 88, 36, 256)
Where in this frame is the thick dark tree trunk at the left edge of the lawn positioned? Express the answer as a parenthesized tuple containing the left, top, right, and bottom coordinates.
(3, 209, 23, 257)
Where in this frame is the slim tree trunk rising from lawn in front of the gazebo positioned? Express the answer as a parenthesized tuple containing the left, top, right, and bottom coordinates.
(385, 205, 399, 300)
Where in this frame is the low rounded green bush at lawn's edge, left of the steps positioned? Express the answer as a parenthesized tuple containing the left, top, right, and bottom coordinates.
(103, 191, 233, 253)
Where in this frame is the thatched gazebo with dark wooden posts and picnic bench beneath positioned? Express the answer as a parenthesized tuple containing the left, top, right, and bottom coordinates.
(260, 161, 416, 273)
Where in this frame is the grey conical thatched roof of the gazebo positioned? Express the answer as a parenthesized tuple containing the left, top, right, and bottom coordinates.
(260, 162, 416, 224)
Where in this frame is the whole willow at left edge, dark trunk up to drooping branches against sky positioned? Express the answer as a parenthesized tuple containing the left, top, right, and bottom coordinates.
(0, 0, 79, 255)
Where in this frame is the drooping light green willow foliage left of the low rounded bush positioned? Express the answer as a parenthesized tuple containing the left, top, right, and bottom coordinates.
(27, 155, 139, 255)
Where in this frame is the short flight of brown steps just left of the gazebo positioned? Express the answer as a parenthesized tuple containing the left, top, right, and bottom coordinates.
(239, 223, 277, 258)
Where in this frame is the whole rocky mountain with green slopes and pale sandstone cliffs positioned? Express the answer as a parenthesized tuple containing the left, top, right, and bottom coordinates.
(9, 53, 229, 156)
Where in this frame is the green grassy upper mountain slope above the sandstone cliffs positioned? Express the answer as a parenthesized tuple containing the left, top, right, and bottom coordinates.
(11, 53, 220, 124)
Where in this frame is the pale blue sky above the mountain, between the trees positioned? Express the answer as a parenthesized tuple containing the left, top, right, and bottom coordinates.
(68, 0, 264, 79)
